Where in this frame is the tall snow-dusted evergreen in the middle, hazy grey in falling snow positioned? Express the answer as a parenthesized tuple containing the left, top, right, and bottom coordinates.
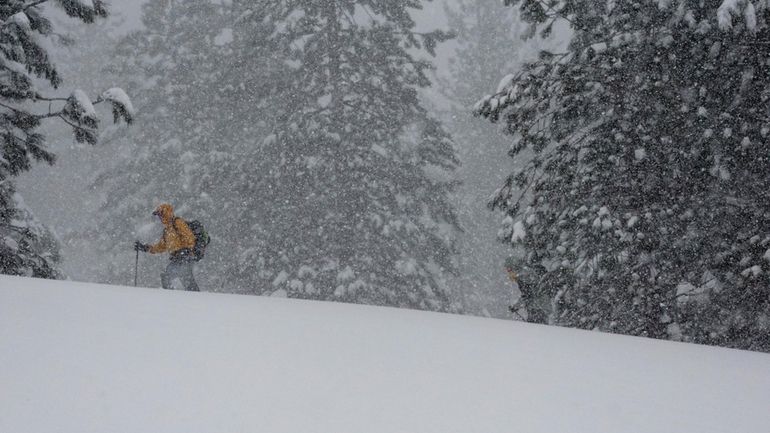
(234, 0, 457, 311)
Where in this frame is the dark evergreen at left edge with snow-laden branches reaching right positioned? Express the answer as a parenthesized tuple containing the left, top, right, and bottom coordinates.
(0, 0, 131, 278)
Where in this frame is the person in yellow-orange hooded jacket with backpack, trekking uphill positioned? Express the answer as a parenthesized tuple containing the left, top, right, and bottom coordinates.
(134, 203, 200, 292)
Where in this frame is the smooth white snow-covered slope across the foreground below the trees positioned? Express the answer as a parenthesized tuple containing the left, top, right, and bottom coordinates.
(0, 276, 770, 433)
